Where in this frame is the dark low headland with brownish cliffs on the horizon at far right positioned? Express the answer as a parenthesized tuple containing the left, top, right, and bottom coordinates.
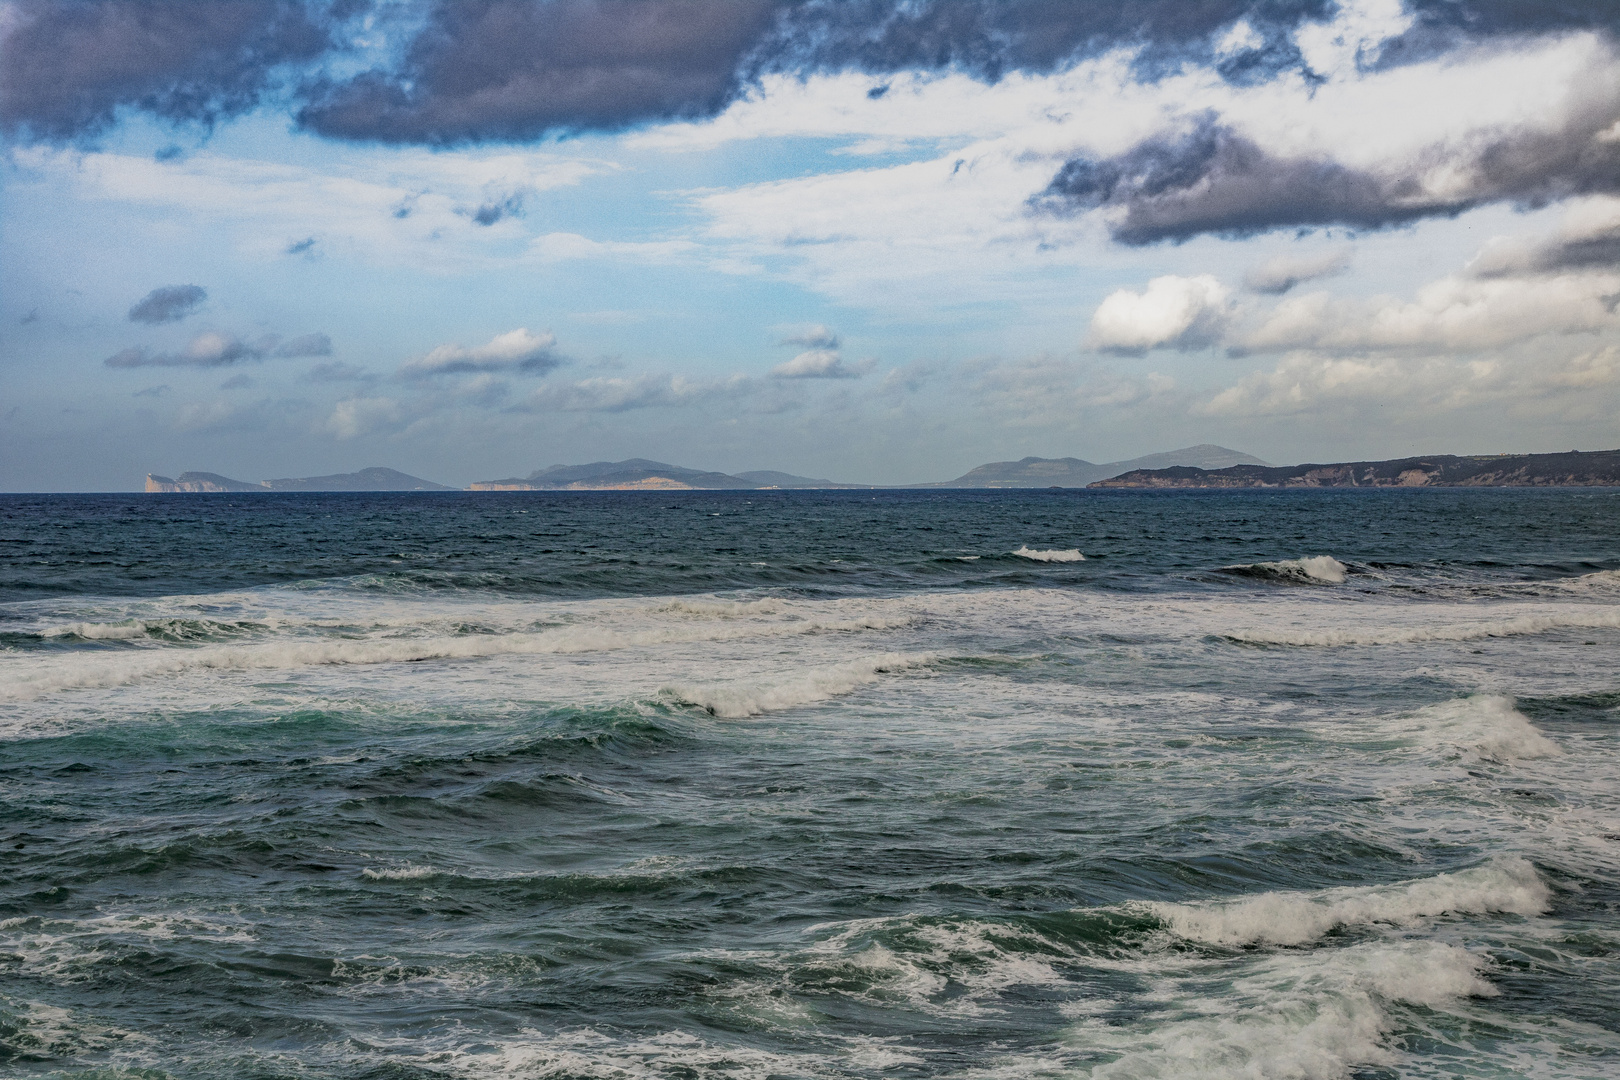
(1090, 450, 1620, 487)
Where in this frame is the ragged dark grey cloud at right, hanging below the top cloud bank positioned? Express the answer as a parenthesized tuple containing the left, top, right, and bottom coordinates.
(1032, 91, 1620, 244)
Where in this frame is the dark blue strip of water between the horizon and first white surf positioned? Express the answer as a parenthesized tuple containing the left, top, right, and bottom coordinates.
(0, 489, 1620, 601)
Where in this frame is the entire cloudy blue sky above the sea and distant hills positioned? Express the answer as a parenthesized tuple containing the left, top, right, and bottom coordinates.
(0, 0, 1620, 491)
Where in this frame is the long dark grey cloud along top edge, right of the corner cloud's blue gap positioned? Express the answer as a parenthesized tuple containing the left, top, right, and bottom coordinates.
(300, 0, 1333, 144)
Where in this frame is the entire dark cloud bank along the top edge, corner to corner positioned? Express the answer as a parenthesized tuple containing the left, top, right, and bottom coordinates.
(9, 0, 1620, 146)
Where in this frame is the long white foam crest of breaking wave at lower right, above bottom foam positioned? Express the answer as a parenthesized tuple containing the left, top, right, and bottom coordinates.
(1145, 855, 1550, 946)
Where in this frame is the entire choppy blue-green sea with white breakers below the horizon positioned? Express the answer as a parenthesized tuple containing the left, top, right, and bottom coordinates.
(0, 489, 1620, 1080)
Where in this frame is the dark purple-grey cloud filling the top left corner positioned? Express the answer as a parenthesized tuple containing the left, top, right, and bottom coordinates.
(0, 0, 330, 141)
